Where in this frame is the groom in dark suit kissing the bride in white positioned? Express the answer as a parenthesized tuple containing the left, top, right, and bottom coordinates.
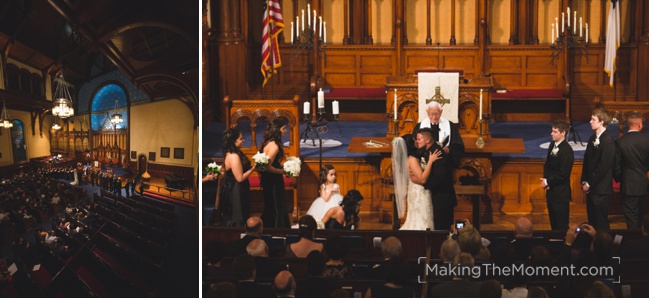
(416, 128, 457, 230)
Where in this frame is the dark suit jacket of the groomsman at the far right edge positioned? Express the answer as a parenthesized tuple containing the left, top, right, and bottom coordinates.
(613, 131, 649, 196)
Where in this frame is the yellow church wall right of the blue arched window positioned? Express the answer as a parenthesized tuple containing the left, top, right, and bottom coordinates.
(129, 99, 198, 167)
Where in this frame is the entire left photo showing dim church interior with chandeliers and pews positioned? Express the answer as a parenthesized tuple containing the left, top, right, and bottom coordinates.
(0, 0, 199, 297)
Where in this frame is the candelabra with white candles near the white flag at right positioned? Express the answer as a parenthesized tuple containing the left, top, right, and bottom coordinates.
(550, 7, 590, 64)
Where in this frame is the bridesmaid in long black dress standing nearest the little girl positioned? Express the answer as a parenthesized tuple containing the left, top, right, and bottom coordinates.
(260, 118, 291, 228)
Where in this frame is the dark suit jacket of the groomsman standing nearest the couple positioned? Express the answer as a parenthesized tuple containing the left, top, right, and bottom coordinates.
(543, 140, 575, 203)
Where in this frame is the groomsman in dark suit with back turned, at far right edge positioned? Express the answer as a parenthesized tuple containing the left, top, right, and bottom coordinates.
(613, 112, 649, 229)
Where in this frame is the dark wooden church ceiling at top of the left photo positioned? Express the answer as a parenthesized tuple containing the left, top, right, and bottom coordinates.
(0, 0, 199, 108)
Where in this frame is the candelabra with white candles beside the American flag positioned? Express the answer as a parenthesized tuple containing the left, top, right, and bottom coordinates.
(290, 4, 327, 65)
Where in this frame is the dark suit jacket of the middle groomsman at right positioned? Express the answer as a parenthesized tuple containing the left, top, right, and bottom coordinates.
(581, 131, 615, 195)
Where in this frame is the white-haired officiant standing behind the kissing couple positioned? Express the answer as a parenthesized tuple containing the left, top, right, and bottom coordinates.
(412, 101, 464, 169)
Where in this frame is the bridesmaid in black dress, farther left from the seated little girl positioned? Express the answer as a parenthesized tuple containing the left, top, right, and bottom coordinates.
(221, 128, 255, 227)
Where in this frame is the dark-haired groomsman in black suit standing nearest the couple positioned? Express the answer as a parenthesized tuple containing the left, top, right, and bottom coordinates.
(541, 120, 575, 231)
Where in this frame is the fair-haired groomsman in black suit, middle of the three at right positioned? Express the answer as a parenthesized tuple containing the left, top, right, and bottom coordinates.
(581, 109, 615, 231)
